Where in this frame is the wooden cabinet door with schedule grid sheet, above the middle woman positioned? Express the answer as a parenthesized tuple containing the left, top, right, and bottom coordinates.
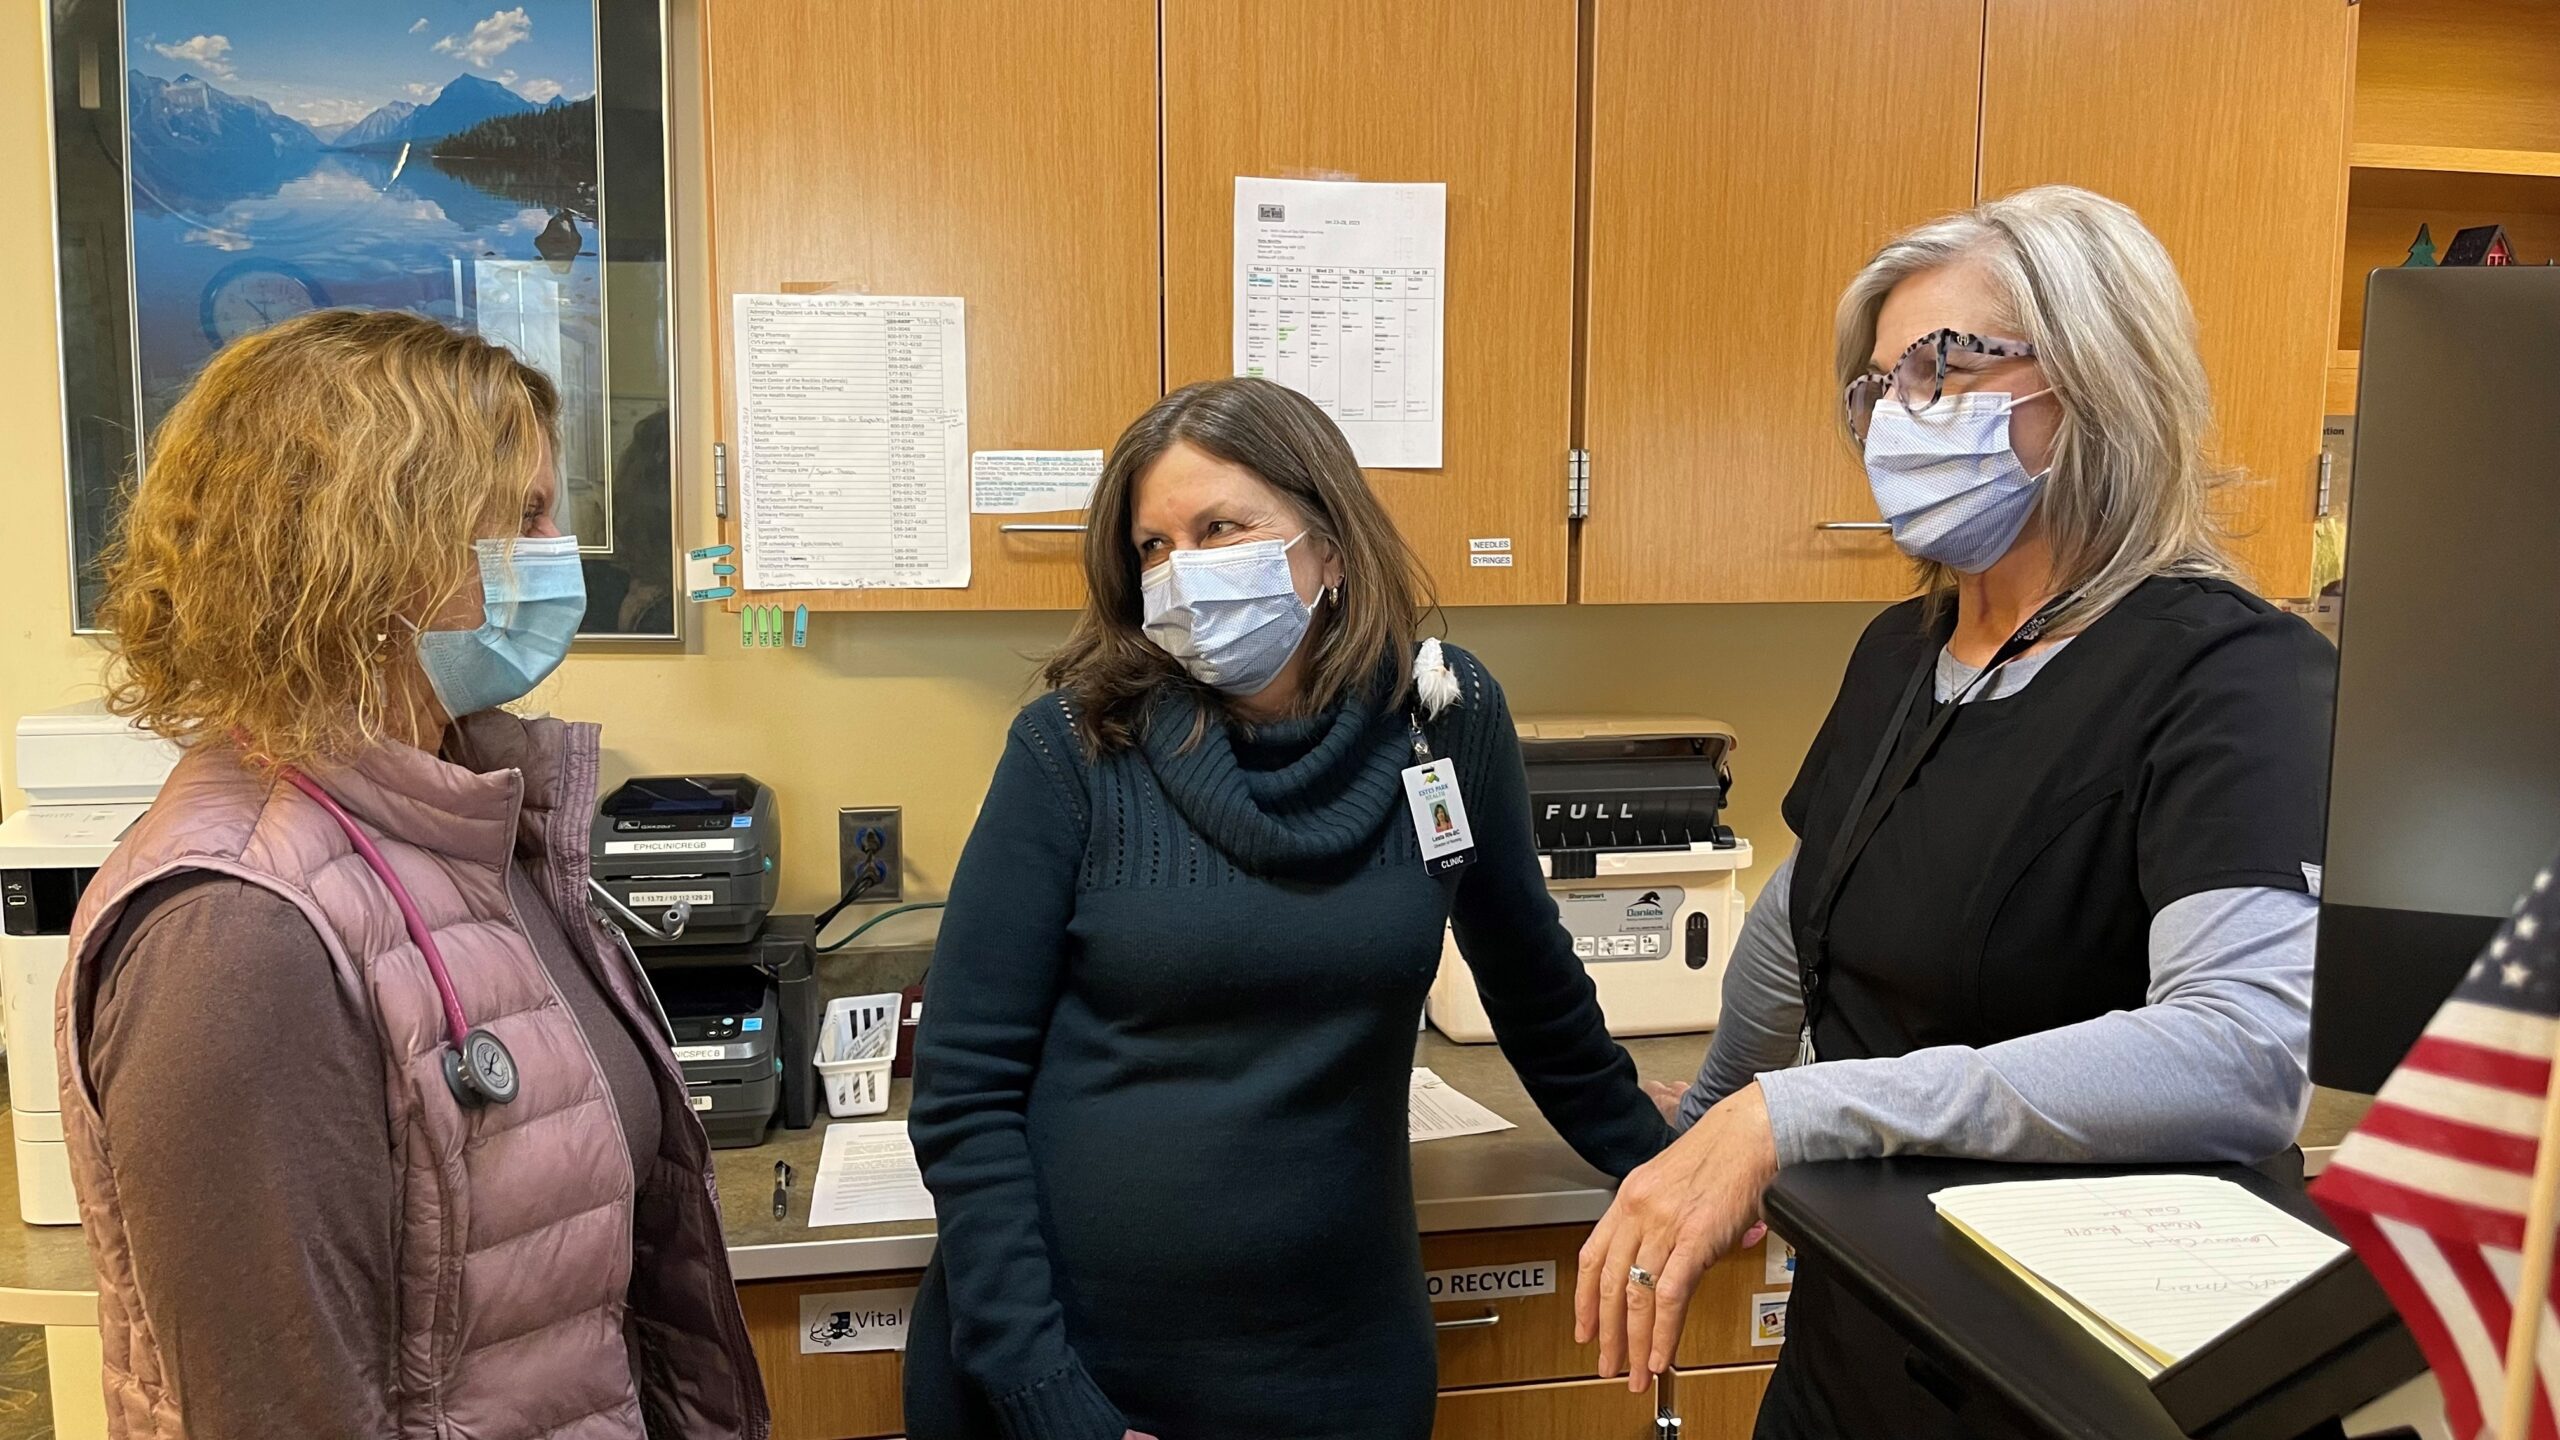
(1162, 0, 1577, 605)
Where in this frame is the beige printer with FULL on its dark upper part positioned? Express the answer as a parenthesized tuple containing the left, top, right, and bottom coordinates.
(1423, 717, 1751, 1043)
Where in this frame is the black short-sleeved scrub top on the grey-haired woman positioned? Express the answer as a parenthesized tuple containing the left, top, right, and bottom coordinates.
(1759, 577, 2337, 1437)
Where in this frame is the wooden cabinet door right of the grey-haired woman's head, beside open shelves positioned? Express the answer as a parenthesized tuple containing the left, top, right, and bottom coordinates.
(1981, 0, 2355, 597)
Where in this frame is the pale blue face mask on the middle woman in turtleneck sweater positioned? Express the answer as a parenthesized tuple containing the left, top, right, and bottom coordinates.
(1137, 533, 1316, 697)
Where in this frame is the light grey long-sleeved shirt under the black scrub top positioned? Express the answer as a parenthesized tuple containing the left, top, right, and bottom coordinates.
(1679, 646, 2319, 1163)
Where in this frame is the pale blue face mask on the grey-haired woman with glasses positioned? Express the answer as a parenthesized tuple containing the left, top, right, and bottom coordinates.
(1866, 389, 2051, 574)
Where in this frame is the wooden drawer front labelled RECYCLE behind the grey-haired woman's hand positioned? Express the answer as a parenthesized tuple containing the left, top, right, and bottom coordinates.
(1423, 1225, 1787, 1389)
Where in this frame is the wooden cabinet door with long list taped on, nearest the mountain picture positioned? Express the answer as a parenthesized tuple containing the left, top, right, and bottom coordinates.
(701, 0, 1162, 610)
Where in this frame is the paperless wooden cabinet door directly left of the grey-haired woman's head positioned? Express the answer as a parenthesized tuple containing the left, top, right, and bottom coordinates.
(1582, 0, 1976, 602)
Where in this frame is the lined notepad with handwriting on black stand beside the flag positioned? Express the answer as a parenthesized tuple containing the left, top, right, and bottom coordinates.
(1930, 1176, 2345, 1376)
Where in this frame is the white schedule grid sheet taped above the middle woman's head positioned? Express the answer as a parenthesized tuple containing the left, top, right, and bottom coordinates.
(1234, 177, 1449, 469)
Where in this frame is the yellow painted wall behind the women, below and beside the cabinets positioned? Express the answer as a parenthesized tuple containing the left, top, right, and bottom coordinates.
(0, 0, 1871, 907)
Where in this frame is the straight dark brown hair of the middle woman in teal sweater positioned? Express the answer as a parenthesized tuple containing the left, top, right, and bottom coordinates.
(1042, 379, 1434, 753)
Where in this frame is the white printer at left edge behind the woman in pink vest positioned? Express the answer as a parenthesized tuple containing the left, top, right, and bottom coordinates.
(0, 700, 179, 1225)
